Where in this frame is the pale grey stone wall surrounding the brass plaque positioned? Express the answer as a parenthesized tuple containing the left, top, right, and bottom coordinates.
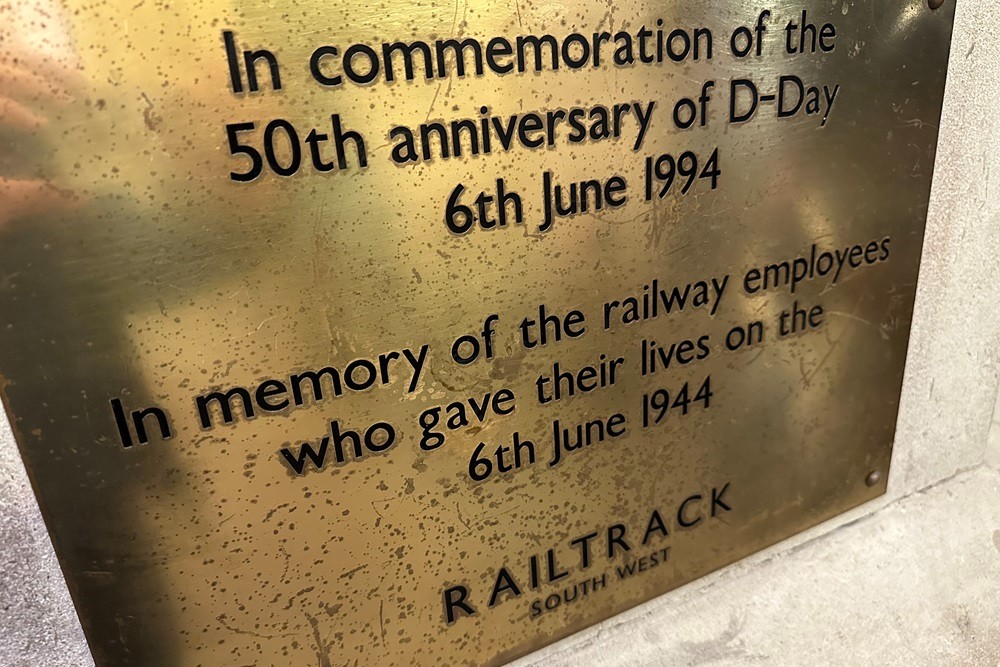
(0, 0, 1000, 667)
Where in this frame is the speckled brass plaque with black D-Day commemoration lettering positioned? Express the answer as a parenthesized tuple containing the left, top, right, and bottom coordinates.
(0, 0, 954, 666)
